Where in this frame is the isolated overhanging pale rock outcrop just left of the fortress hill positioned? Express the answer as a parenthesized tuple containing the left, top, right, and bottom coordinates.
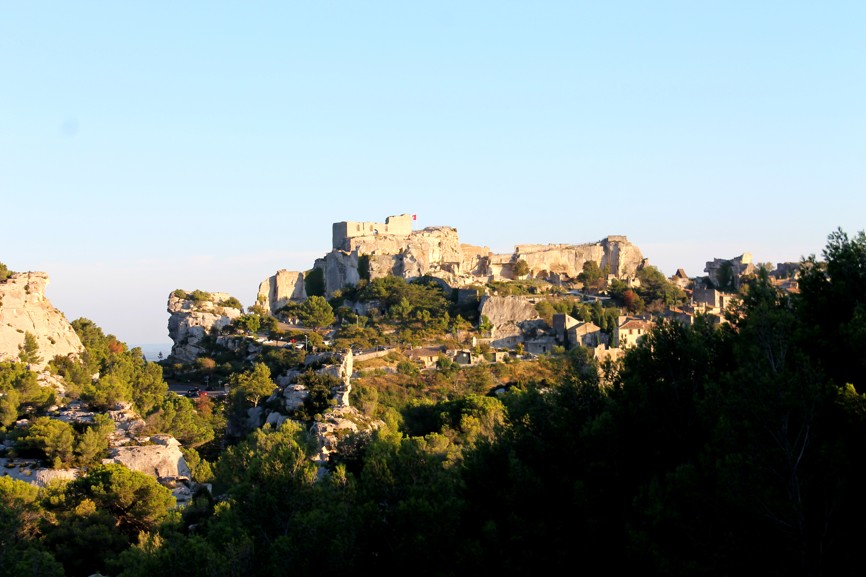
(168, 291, 243, 363)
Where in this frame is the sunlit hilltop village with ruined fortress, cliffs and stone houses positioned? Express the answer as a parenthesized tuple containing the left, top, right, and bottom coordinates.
(168, 214, 799, 368)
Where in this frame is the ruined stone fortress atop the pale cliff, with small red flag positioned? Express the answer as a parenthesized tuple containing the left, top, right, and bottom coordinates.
(314, 214, 646, 296)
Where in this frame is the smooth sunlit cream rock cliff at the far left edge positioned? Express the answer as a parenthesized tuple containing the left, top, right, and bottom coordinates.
(0, 272, 84, 370)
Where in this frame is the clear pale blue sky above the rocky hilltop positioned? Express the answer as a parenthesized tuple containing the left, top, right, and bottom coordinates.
(0, 0, 866, 344)
